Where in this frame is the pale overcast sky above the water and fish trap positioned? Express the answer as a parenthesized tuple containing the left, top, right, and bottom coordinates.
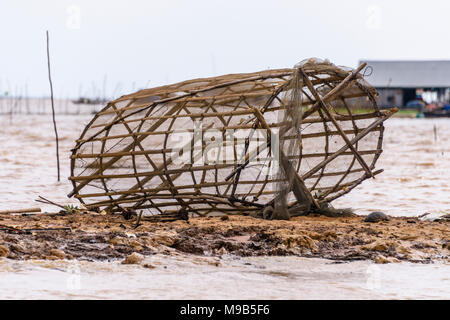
(0, 0, 450, 97)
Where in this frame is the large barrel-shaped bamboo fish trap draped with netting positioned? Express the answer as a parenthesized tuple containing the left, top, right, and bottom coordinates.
(69, 59, 396, 216)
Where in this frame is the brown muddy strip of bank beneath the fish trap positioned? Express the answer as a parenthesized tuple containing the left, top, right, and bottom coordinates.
(0, 213, 450, 263)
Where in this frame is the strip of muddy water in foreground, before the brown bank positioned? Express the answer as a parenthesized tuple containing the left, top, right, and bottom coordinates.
(0, 255, 450, 300)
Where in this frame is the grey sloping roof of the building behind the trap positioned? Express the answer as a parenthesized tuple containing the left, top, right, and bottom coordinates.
(360, 60, 450, 88)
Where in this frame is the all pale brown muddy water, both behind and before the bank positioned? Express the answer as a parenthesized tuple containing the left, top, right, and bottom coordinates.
(0, 115, 450, 299)
